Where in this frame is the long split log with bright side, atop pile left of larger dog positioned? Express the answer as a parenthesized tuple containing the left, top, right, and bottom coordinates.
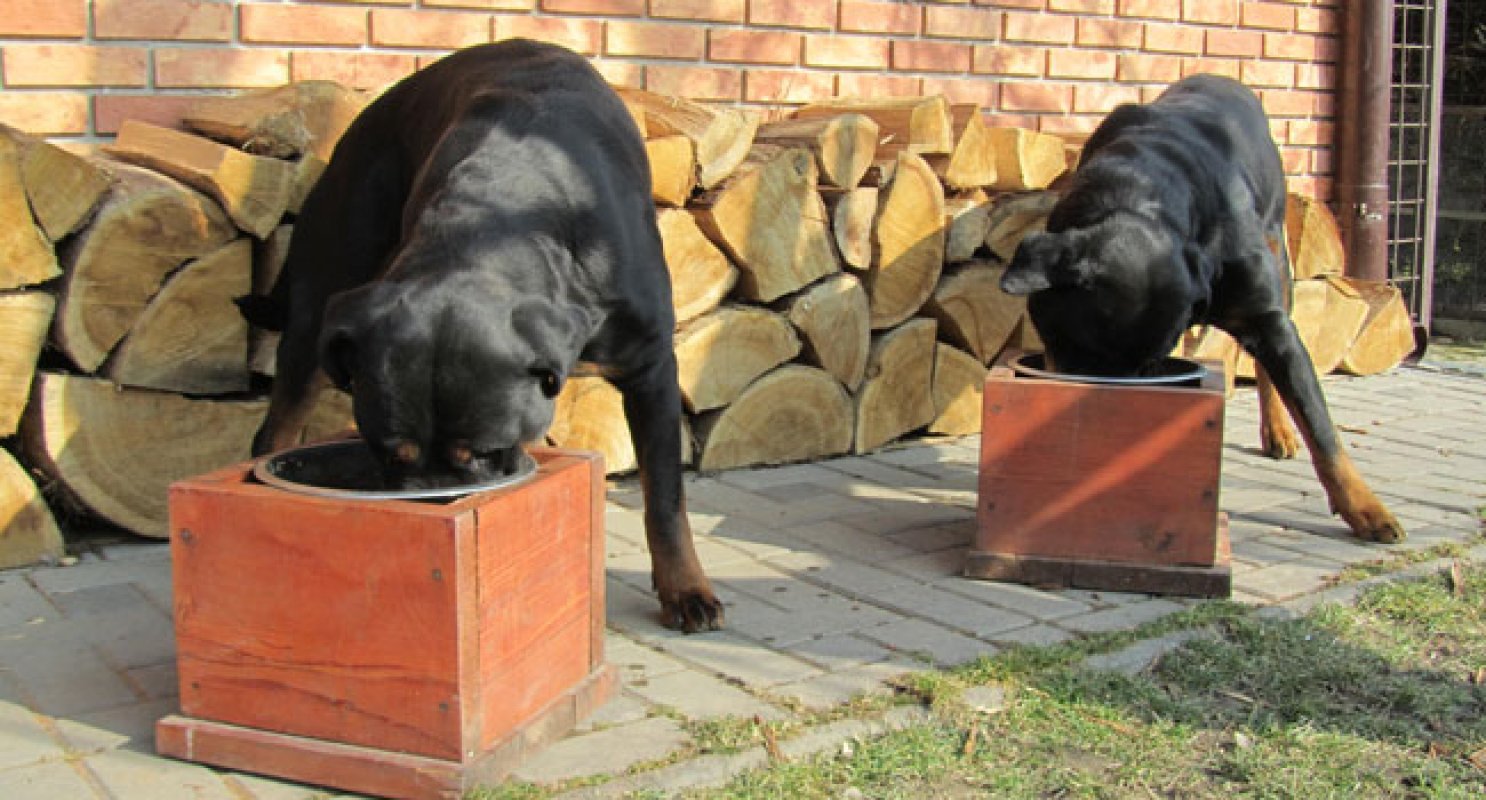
(104, 119, 294, 239)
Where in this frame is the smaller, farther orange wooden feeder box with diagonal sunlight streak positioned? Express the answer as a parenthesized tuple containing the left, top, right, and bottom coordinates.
(966, 363, 1232, 596)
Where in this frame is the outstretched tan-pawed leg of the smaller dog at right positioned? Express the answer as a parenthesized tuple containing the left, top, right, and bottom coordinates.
(1244, 311, 1406, 543)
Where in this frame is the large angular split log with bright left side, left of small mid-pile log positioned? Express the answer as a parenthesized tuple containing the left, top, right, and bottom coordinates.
(692, 149, 841, 302)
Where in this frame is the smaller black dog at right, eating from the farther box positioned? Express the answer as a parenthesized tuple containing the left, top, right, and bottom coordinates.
(1002, 76, 1404, 541)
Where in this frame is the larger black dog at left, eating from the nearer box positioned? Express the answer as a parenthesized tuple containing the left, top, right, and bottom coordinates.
(241, 40, 722, 630)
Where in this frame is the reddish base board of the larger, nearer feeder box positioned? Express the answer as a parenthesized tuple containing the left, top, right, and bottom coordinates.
(155, 665, 618, 800)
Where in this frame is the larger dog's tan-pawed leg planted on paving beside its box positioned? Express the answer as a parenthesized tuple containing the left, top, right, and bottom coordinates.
(615, 349, 724, 633)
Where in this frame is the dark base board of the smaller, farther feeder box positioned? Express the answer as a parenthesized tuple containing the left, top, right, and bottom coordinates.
(964, 513, 1233, 598)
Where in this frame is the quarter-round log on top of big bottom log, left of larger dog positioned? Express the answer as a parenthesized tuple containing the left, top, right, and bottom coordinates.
(106, 238, 253, 394)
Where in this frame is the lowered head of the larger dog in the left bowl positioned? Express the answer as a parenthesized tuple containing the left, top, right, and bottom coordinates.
(319, 276, 583, 489)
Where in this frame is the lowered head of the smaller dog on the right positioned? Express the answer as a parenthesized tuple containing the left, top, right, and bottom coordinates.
(1002, 213, 1208, 378)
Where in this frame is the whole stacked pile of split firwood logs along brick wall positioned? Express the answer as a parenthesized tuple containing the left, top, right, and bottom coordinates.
(0, 82, 1412, 567)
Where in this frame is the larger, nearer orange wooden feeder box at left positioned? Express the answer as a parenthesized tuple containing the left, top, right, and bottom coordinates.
(156, 451, 615, 797)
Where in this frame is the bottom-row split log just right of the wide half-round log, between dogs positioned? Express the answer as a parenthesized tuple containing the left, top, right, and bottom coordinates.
(853, 320, 936, 454)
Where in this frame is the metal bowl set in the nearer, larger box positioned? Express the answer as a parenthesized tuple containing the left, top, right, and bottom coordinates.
(253, 439, 536, 500)
